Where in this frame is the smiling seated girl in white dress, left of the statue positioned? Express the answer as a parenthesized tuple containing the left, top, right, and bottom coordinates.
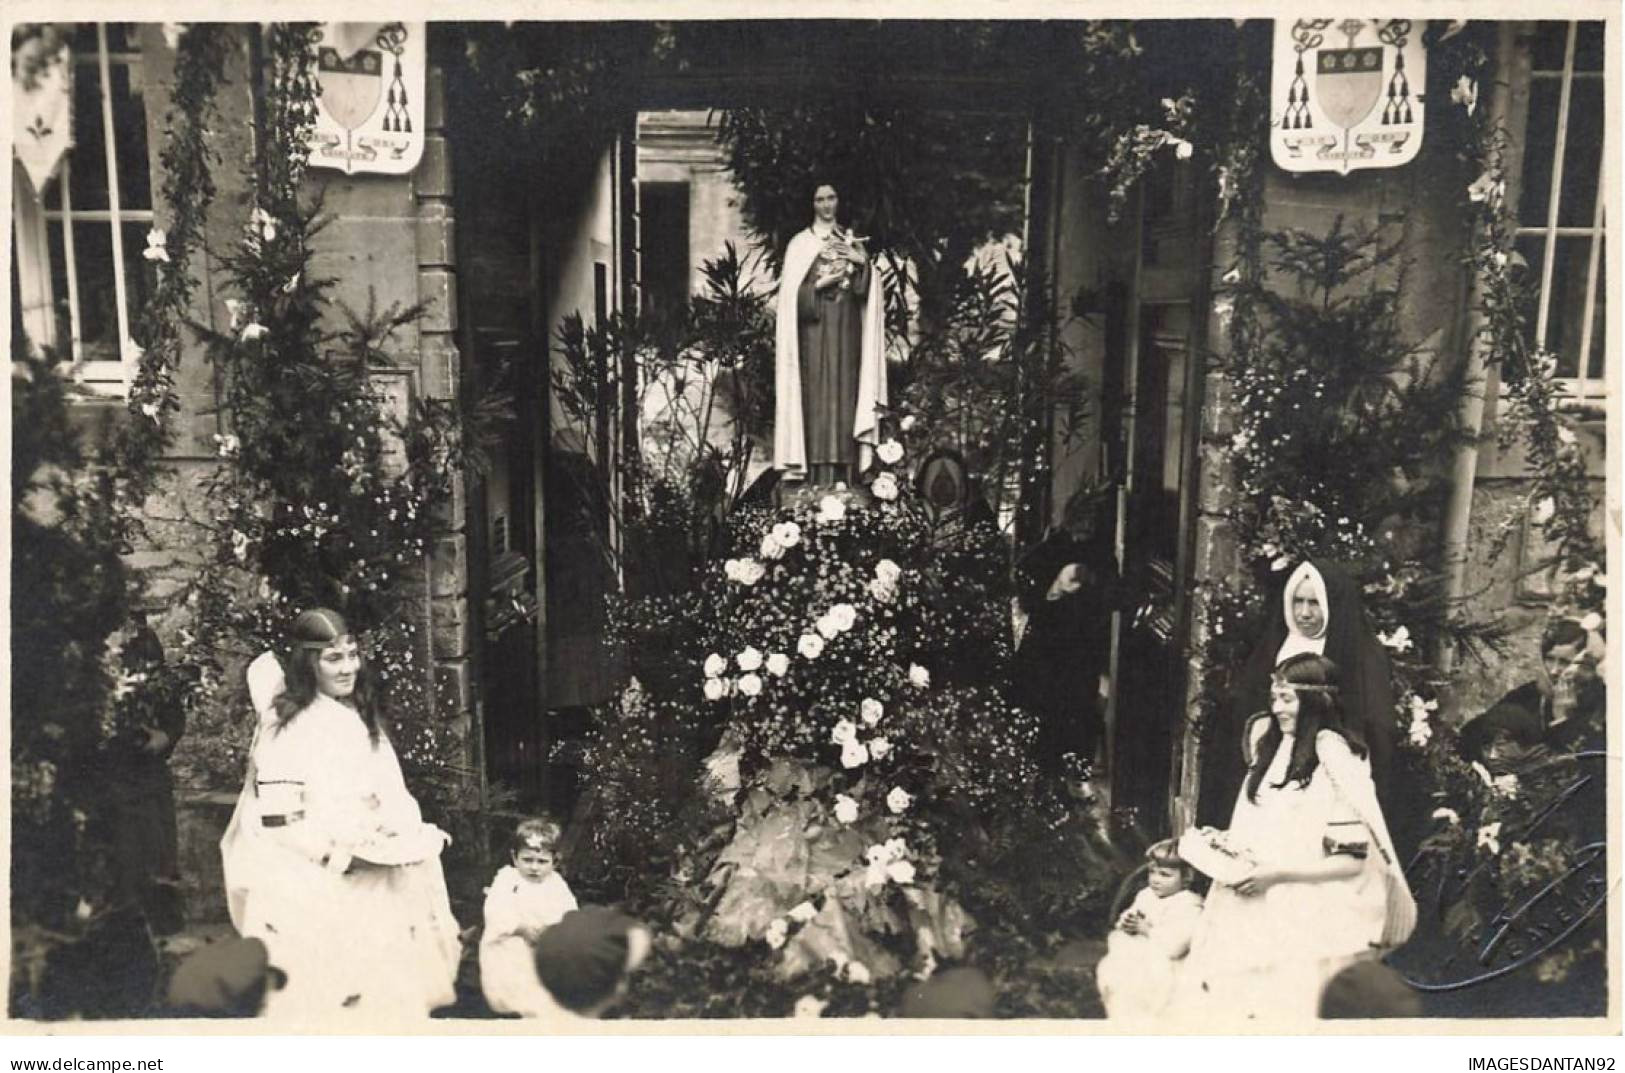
(221, 608, 462, 1023)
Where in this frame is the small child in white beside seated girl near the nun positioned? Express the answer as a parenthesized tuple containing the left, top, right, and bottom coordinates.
(1095, 839, 1203, 1019)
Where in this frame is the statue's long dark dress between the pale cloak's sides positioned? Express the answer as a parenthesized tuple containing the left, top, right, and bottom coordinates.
(796, 263, 869, 480)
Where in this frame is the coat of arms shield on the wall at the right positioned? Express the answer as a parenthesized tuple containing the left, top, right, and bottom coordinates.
(1269, 18, 1427, 174)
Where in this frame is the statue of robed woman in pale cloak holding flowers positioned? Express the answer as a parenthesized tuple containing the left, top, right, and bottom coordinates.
(774, 182, 886, 484)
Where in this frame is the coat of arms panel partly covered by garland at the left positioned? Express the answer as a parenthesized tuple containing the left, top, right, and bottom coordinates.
(310, 23, 427, 176)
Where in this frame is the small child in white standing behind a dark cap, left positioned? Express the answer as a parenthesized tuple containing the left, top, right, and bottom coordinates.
(479, 819, 575, 1018)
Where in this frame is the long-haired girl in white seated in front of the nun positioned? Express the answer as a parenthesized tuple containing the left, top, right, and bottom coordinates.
(1175, 654, 1415, 1023)
